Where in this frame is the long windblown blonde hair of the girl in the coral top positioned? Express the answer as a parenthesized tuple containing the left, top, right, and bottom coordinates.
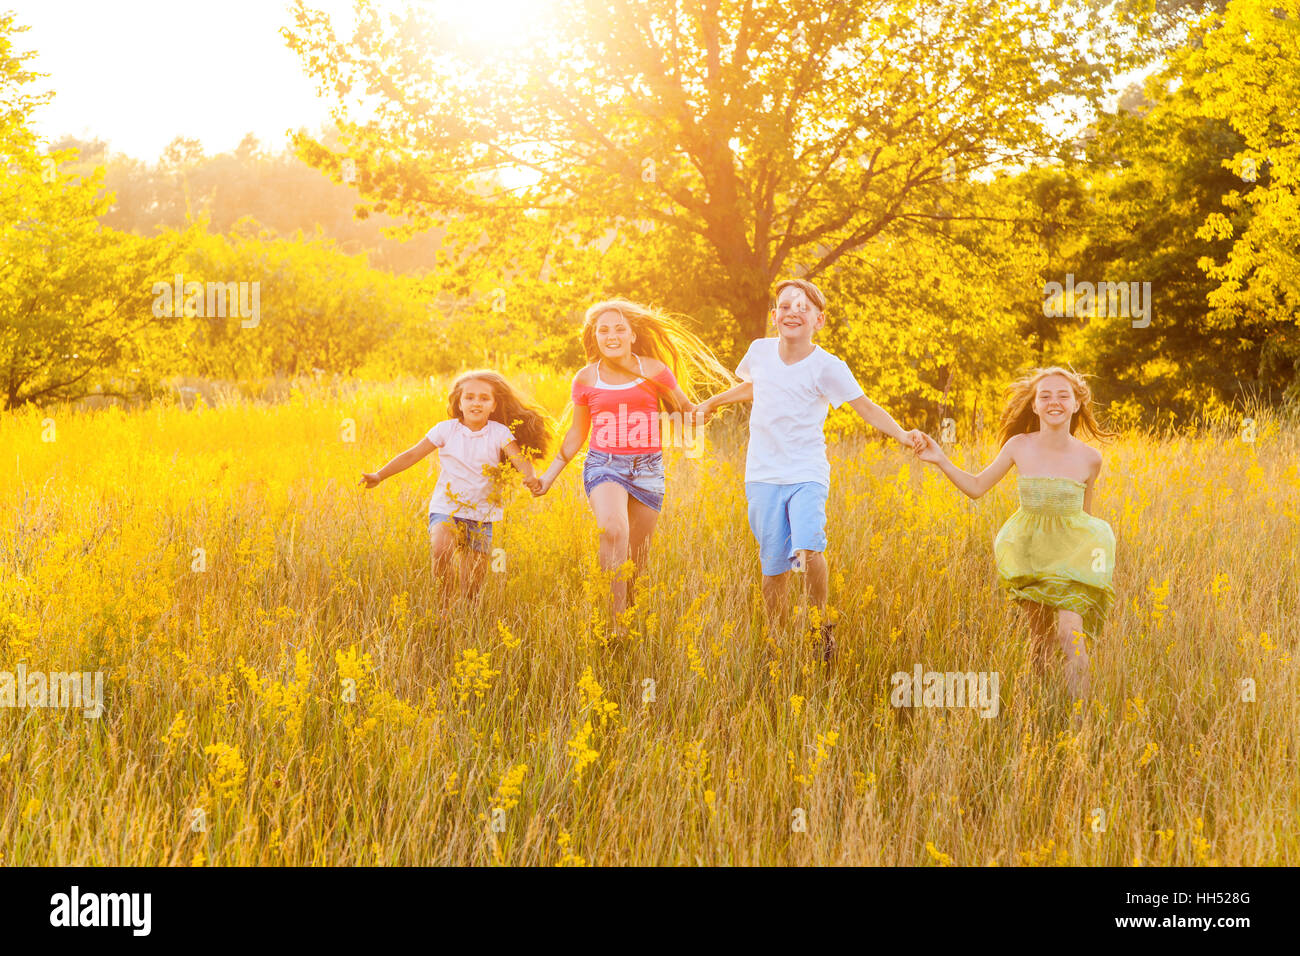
(581, 299, 736, 405)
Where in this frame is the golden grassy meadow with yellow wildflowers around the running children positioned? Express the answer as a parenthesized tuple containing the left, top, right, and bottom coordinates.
(0, 375, 1300, 866)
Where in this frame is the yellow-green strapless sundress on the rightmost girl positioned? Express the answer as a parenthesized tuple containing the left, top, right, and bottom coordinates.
(993, 477, 1115, 637)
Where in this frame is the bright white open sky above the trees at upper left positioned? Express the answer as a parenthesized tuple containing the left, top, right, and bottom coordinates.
(12, 0, 369, 161)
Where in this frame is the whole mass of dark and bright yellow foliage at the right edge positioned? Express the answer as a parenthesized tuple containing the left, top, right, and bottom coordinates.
(1047, 3, 1300, 421)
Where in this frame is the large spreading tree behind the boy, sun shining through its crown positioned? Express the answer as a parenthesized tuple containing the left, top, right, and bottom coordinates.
(286, 0, 1159, 356)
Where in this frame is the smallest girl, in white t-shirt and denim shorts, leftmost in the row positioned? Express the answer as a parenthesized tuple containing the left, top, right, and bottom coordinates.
(360, 371, 550, 596)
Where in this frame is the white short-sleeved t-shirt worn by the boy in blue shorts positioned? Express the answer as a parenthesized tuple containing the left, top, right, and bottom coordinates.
(736, 338, 863, 488)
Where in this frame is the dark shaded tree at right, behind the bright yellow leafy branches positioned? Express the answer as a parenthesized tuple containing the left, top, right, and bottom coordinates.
(1047, 66, 1264, 419)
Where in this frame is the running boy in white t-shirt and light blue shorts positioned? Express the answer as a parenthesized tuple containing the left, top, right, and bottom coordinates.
(696, 278, 924, 662)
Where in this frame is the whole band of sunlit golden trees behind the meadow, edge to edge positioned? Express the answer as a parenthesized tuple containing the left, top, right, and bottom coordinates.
(0, 0, 1300, 423)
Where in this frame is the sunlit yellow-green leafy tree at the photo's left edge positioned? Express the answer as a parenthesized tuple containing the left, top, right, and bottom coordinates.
(0, 17, 187, 408)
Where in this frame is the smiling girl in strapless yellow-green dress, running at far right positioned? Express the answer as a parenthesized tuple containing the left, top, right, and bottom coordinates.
(918, 367, 1115, 698)
